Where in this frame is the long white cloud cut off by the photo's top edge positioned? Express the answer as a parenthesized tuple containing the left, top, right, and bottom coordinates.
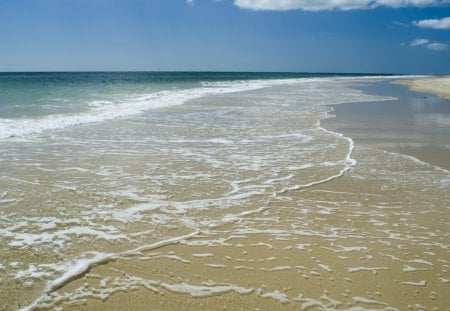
(234, 0, 450, 11)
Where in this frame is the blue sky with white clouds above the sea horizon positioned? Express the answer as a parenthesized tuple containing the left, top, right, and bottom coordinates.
(0, 0, 450, 74)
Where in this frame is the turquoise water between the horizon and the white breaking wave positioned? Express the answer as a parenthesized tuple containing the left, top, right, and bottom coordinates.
(0, 72, 352, 119)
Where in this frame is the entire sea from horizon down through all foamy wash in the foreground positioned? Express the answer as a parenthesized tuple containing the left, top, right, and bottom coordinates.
(0, 72, 450, 310)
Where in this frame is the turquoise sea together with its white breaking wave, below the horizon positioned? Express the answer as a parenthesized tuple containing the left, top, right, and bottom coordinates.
(0, 72, 370, 138)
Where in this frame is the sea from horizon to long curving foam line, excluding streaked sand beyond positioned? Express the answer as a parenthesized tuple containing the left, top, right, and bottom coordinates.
(0, 73, 447, 310)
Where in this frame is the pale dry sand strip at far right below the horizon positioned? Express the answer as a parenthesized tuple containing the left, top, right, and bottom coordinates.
(395, 76, 450, 99)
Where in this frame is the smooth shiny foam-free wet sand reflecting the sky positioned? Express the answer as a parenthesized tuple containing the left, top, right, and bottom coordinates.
(324, 78, 450, 170)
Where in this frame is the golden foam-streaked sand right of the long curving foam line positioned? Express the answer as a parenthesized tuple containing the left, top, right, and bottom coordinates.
(26, 79, 450, 310)
